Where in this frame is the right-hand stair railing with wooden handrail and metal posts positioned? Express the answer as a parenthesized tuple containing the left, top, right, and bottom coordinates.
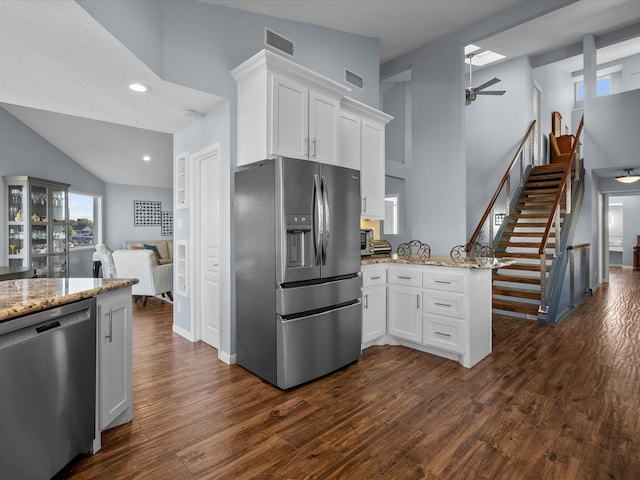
(538, 115, 584, 313)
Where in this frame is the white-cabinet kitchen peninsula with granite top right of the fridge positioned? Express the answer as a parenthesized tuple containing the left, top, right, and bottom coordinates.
(361, 255, 513, 368)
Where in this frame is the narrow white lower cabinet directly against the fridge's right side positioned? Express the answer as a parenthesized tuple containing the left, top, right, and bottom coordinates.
(362, 266, 387, 348)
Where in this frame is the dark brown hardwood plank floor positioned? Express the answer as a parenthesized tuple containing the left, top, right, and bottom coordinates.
(57, 269, 640, 480)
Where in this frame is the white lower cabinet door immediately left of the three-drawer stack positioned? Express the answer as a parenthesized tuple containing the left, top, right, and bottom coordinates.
(389, 285, 422, 343)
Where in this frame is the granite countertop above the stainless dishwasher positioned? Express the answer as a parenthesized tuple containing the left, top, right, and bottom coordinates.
(0, 278, 138, 323)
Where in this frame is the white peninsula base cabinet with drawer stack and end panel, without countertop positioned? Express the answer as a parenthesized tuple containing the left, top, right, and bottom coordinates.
(363, 264, 491, 368)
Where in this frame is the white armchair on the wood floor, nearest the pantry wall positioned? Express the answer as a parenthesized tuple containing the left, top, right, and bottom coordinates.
(112, 250, 173, 305)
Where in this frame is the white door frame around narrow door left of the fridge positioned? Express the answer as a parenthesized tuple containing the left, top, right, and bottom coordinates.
(188, 143, 220, 342)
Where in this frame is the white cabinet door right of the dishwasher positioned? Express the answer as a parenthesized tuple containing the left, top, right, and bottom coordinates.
(98, 289, 132, 430)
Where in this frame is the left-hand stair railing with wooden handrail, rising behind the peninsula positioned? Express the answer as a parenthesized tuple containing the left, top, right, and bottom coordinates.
(465, 120, 536, 253)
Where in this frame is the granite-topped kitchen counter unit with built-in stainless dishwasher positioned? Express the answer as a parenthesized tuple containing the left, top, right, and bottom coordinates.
(0, 278, 138, 478)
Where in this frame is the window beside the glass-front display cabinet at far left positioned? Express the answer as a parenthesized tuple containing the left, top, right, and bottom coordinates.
(69, 192, 102, 251)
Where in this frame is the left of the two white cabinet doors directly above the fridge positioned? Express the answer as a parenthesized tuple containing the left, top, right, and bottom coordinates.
(270, 73, 309, 159)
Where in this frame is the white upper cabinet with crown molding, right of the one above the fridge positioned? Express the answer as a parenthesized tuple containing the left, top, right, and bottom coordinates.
(338, 97, 393, 220)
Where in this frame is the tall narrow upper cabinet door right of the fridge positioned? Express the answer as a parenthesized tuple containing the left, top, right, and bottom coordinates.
(360, 118, 384, 220)
